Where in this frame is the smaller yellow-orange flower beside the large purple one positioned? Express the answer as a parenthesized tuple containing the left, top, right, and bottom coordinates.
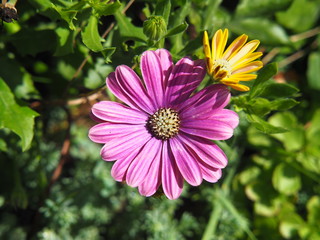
(203, 29, 263, 91)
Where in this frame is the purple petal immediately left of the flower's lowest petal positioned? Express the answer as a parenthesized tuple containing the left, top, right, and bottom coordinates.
(139, 144, 162, 197)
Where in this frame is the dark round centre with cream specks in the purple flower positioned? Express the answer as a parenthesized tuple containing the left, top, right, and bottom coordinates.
(147, 108, 180, 140)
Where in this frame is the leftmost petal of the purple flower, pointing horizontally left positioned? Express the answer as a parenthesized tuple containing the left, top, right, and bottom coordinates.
(89, 122, 146, 143)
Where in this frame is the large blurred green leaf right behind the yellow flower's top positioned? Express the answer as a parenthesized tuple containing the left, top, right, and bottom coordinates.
(229, 18, 291, 47)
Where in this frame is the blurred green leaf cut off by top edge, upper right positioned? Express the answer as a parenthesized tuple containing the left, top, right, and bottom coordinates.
(236, 0, 292, 17)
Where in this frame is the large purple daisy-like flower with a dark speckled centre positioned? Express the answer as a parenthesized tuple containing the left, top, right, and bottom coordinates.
(89, 49, 239, 199)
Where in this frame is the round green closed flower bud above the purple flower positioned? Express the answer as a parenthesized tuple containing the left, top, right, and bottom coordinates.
(143, 16, 167, 41)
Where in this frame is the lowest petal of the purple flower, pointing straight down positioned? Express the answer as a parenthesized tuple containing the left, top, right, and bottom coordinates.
(161, 141, 183, 199)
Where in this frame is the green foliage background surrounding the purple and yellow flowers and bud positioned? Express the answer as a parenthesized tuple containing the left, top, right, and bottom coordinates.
(0, 0, 320, 240)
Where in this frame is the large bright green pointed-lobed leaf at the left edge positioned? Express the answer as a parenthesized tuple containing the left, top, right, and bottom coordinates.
(0, 78, 39, 151)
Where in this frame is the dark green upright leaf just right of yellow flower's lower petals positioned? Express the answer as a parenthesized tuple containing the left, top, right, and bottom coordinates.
(249, 63, 278, 98)
